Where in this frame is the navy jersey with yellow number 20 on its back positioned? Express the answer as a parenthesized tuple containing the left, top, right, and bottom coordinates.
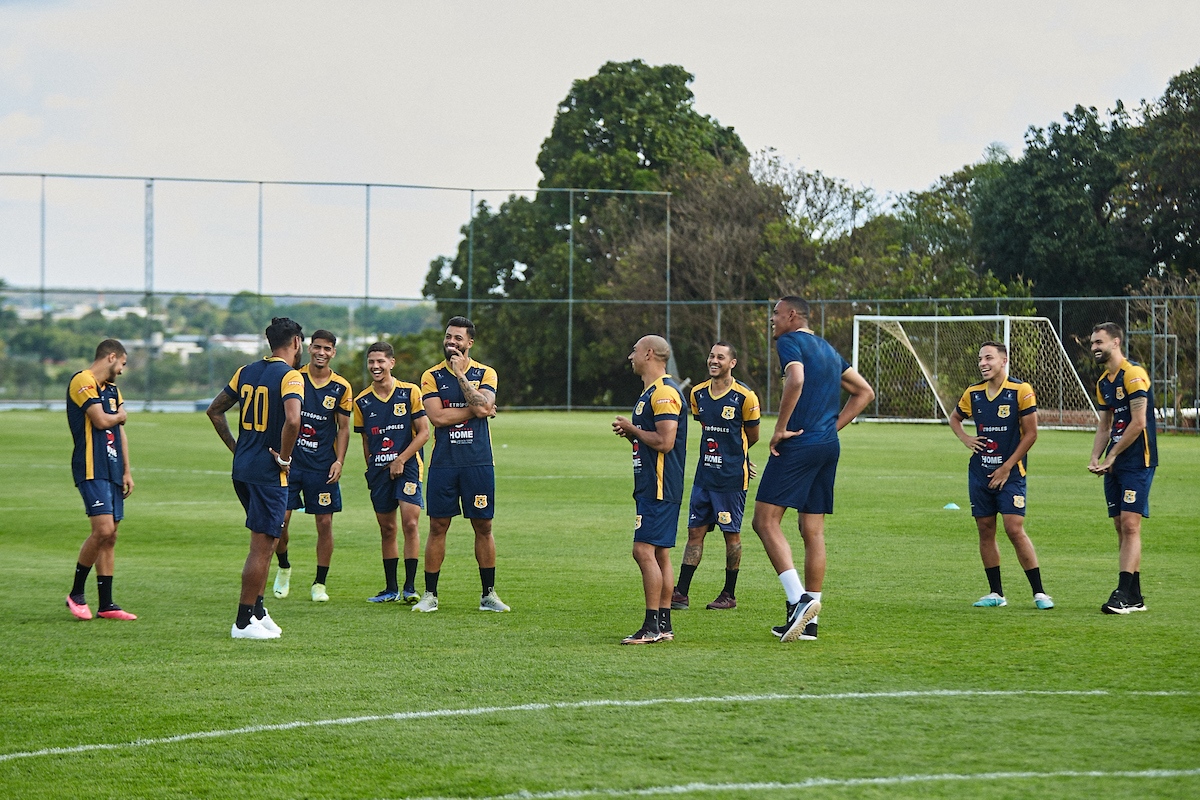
(222, 356, 304, 486)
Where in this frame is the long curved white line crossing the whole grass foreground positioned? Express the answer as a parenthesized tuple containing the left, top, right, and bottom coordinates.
(0, 688, 1194, 762)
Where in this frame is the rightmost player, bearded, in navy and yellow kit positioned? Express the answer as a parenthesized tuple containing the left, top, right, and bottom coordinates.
(1087, 323, 1158, 614)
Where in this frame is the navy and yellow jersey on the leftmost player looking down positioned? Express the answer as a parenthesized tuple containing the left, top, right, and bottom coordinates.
(67, 369, 125, 486)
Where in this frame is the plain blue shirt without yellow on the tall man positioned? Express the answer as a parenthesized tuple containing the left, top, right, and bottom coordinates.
(775, 331, 850, 452)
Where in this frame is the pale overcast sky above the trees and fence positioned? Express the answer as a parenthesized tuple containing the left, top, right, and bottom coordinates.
(0, 0, 1200, 302)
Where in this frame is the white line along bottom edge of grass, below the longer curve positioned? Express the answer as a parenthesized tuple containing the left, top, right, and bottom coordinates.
(393, 769, 1200, 800)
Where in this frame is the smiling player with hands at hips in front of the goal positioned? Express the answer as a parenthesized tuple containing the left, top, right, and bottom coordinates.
(950, 342, 1054, 609)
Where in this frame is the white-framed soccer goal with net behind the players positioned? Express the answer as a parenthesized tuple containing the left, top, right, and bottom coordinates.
(854, 315, 1098, 427)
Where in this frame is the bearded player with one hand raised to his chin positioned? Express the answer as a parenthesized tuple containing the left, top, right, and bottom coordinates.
(413, 317, 509, 612)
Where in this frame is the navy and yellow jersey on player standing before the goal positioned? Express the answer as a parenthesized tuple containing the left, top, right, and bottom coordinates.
(958, 377, 1038, 482)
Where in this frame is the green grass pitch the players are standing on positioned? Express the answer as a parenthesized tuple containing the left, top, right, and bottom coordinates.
(0, 411, 1200, 799)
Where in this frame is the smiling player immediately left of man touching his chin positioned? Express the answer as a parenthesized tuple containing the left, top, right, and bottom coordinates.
(354, 342, 430, 606)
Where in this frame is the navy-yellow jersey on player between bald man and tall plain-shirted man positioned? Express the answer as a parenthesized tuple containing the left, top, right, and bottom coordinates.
(690, 380, 760, 492)
